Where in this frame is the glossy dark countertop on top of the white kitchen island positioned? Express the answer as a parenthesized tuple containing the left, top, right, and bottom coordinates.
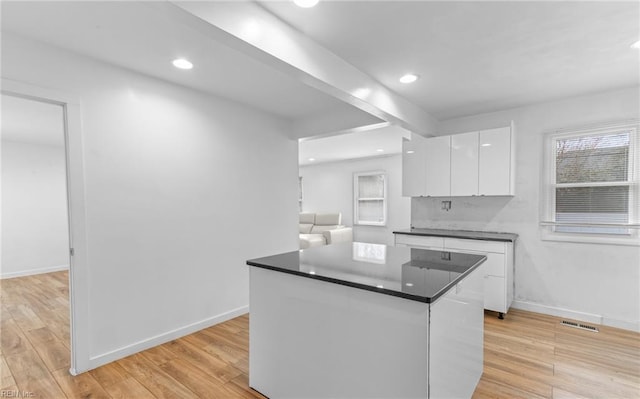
(247, 242, 487, 303)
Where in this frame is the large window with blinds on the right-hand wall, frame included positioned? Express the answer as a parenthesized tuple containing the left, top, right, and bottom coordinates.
(541, 122, 640, 245)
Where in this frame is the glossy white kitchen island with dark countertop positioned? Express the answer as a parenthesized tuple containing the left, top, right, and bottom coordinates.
(247, 242, 486, 399)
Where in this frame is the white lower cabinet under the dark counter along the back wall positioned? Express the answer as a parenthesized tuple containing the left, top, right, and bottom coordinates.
(395, 234, 514, 318)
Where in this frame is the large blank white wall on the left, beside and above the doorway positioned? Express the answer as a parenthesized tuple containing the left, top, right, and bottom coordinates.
(2, 33, 298, 371)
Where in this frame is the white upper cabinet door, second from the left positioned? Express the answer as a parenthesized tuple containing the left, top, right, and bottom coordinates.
(425, 136, 451, 197)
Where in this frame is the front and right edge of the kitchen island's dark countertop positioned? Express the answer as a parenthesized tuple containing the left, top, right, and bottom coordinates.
(247, 256, 487, 303)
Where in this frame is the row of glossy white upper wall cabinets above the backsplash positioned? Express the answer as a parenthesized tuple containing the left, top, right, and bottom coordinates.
(402, 122, 515, 197)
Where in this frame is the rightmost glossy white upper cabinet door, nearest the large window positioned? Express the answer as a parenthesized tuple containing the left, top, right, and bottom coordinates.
(478, 127, 513, 195)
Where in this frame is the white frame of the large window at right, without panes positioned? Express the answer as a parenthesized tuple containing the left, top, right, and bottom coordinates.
(540, 120, 640, 246)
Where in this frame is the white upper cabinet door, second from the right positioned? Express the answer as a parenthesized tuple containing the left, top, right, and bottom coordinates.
(451, 132, 478, 196)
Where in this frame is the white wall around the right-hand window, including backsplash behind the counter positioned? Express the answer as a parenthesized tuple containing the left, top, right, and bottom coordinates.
(412, 88, 640, 330)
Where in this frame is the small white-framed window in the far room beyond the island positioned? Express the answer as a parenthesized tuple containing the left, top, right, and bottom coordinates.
(353, 172, 387, 226)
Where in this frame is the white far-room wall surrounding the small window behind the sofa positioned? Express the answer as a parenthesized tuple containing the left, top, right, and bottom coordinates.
(300, 154, 411, 245)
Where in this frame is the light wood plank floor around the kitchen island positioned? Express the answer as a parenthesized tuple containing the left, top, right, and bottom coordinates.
(0, 272, 640, 399)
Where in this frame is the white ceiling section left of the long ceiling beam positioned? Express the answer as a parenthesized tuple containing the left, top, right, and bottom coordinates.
(0, 1, 361, 119)
